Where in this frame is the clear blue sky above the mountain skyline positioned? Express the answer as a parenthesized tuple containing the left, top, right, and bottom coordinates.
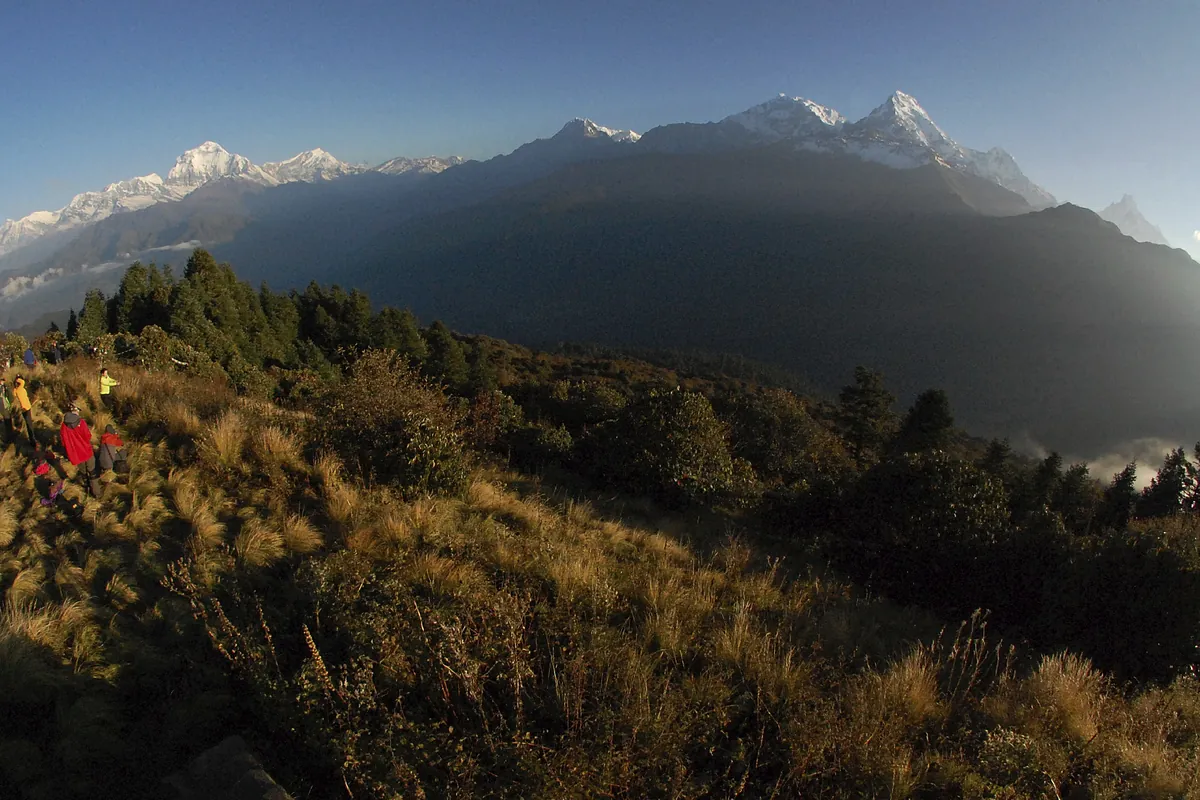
(0, 0, 1200, 255)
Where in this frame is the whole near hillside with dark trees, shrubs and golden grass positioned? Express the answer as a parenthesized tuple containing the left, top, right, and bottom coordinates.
(0, 251, 1200, 798)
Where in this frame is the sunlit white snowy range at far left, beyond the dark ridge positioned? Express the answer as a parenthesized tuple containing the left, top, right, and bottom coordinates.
(0, 142, 463, 257)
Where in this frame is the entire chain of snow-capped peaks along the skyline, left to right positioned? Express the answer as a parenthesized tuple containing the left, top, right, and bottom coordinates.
(0, 91, 1165, 269)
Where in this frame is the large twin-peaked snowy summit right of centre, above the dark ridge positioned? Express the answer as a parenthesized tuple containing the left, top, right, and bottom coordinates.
(722, 91, 1055, 209)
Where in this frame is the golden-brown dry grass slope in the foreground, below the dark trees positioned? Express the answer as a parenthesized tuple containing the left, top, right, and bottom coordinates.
(0, 360, 1200, 798)
